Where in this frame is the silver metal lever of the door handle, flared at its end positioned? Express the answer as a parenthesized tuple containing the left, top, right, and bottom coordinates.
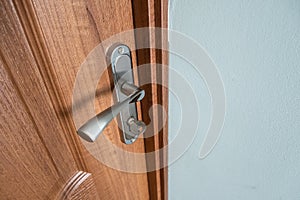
(77, 82, 145, 142)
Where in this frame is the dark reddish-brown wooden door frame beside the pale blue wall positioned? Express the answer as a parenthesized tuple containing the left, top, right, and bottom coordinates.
(132, 0, 168, 199)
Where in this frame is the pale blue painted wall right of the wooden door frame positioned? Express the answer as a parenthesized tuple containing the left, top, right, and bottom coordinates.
(169, 0, 300, 200)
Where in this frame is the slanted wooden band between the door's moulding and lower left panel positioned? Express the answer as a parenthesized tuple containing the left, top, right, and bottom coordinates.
(0, 1, 75, 178)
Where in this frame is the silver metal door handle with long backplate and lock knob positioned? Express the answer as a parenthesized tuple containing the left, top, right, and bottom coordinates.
(77, 44, 146, 144)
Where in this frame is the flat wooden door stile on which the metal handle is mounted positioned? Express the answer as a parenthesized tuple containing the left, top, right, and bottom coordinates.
(24, 0, 149, 199)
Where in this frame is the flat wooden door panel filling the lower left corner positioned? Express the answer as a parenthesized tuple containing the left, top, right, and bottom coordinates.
(0, 61, 62, 199)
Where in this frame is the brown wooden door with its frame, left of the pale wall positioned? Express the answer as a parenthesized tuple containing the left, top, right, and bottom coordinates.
(0, 0, 167, 199)
